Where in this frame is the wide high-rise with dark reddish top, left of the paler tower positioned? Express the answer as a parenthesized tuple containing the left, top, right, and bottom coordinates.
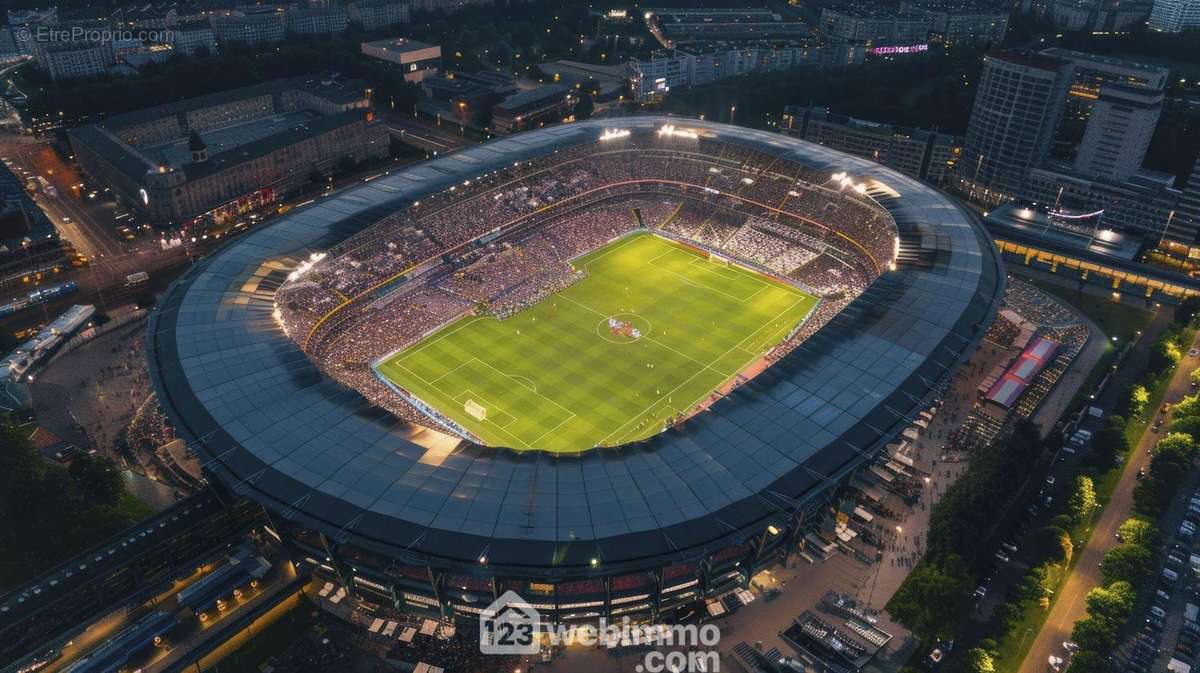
(956, 52, 1073, 203)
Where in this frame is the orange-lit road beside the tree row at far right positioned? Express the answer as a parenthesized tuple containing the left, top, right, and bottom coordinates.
(1020, 326, 1200, 673)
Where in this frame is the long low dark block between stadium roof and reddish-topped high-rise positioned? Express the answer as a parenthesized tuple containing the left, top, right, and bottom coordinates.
(779, 106, 962, 185)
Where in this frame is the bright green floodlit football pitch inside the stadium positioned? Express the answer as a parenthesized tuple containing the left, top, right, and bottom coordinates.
(378, 233, 817, 452)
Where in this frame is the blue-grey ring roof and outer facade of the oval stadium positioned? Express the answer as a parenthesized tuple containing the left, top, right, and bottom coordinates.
(146, 116, 1004, 620)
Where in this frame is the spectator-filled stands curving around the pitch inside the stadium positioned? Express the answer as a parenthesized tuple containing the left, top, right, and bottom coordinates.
(276, 138, 895, 439)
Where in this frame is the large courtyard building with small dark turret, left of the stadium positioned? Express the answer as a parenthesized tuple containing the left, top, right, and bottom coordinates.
(68, 78, 388, 227)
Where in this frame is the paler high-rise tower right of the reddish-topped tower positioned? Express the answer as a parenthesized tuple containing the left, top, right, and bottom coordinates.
(1075, 84, 1163, 180)
